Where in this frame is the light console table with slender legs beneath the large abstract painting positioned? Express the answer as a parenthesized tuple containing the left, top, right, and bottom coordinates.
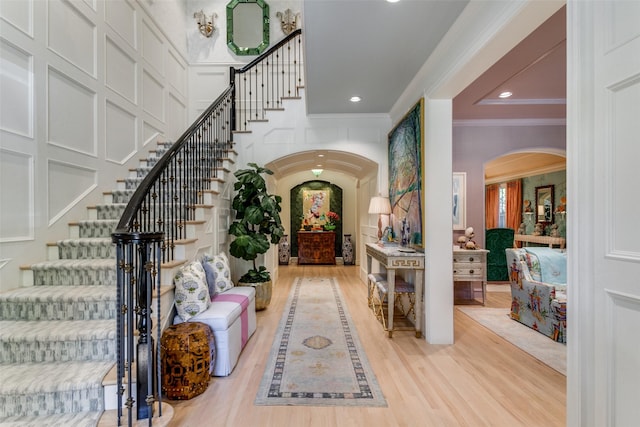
(366, 243, 424, 338)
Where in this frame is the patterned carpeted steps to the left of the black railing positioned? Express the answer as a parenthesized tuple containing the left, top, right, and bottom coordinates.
(0, 144, 176, 427)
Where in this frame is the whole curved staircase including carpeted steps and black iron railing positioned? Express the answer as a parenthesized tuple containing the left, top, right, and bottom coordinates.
(0, 30, 304, 427)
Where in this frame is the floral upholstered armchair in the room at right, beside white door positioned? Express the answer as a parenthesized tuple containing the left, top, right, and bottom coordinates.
(505, 247, 567, 343)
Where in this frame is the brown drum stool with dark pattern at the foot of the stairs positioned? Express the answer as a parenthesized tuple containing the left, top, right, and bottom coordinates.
(160, 322, 216, 400)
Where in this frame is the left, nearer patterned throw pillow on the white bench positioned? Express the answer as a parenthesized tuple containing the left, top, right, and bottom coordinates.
(173, 261, 211, 322)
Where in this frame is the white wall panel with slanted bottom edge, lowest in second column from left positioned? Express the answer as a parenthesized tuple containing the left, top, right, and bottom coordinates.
(47, 160, 98, 225)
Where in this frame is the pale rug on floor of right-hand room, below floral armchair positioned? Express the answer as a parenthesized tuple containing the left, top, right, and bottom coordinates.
(456, 307, 567, 376)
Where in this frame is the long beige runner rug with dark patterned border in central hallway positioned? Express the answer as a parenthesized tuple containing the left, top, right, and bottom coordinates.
(255, 278, 387, 406)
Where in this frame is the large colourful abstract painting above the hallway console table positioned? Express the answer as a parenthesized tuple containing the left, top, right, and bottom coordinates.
(389, 99, 424, 246)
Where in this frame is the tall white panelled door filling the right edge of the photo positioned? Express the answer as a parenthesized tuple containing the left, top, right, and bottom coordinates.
(567, 0, 640, 427)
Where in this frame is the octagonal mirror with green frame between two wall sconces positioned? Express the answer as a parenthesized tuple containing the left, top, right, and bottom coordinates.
(227, 0, 269, 55)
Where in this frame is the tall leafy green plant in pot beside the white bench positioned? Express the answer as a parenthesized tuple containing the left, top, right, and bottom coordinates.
(229, 163, 284, 310)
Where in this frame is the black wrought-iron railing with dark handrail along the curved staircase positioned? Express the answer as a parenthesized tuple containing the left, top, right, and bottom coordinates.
(112, 30, 303, 426)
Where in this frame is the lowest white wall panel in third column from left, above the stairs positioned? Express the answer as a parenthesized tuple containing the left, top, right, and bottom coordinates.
(105, 101, 138, 164)
